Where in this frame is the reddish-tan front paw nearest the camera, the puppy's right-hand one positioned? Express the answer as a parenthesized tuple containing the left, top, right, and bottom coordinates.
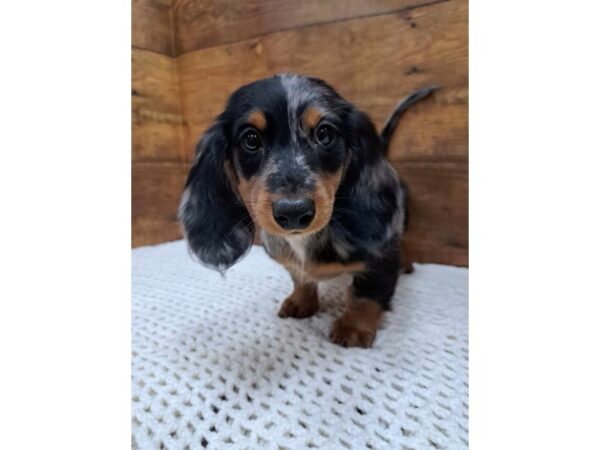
(329, 287, 383, 348)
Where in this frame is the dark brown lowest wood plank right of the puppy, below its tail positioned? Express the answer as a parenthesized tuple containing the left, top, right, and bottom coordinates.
(394, 162, 469, 266)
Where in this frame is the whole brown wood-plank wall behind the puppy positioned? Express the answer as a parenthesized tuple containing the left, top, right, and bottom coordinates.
(132, 0, 468, 265)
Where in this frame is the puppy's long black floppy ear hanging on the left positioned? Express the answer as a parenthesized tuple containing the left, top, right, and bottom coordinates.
(179, 123, 255, 272)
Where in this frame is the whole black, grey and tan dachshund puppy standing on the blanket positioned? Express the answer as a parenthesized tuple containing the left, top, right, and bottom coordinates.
(179, 74, 435, 347)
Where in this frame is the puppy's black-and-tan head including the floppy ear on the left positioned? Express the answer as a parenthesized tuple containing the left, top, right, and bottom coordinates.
(180, 75, 378, 270)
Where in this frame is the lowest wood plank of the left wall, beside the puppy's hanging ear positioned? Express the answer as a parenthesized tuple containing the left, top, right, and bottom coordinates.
(131, 163, 187, 247)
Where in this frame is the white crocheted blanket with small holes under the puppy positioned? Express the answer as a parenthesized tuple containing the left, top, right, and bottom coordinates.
(132, 241, 468, 450)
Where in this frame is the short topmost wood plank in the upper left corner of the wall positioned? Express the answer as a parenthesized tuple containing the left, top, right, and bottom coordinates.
(131, 0, 175, 56)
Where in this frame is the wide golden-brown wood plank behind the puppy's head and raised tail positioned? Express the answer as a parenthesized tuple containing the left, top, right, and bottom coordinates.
(177, 0, 468, 161)
